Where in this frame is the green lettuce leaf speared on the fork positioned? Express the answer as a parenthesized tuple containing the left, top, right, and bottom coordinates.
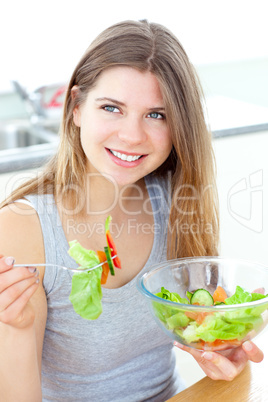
(68, 240, 102, 320)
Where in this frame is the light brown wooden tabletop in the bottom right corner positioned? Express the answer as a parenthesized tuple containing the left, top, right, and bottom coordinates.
(168, 332, 268, 402)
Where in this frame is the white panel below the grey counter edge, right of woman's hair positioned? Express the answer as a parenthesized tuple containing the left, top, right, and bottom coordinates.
(214, 132, 268, 266)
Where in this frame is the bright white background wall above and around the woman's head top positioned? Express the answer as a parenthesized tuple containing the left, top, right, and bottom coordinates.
(0, 0, 268, 91)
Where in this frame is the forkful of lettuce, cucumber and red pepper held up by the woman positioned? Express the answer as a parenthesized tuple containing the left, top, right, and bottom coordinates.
(68, 216, 121, 320)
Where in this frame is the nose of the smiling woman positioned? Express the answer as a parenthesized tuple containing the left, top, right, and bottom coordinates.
(118, 118, 147, 146)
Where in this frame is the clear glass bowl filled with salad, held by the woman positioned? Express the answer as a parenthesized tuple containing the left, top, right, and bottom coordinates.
(137, 257, 268, 351)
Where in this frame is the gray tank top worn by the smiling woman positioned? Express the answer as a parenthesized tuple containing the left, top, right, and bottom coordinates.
(26, 176, 184, 402)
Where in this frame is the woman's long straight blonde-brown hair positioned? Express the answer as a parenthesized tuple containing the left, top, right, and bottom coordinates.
(2, 20, 219, 258)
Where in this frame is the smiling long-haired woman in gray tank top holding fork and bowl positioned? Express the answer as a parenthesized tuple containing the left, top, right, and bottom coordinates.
(0, 21, 262, 402)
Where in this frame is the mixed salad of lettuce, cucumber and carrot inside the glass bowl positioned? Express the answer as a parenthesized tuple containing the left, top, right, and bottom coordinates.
(153, 286, 268, 350)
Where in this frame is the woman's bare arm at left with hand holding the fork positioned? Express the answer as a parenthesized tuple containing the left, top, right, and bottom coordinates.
(0, 204, 47, 402)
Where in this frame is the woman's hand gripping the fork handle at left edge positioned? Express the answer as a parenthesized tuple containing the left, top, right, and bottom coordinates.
(0, 255, 39, 329)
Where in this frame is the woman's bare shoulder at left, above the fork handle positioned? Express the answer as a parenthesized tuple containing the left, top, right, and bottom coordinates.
(0, 203, 45, 264)
